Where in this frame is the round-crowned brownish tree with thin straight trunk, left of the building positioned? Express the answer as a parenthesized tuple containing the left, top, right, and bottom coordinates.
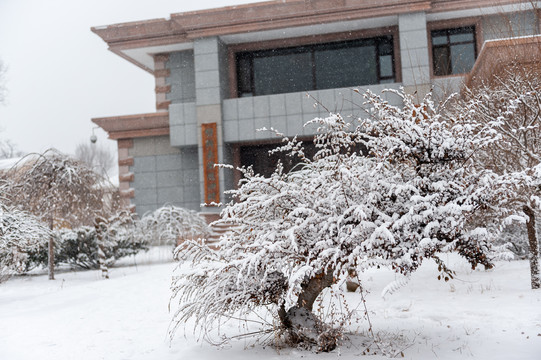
(5, 150, 105, 279)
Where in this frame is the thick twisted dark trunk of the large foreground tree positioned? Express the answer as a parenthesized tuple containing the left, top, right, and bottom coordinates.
(278, 269, 338, 351)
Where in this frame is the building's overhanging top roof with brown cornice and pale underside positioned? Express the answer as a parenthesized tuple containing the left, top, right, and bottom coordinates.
(92, 0, 529, 73)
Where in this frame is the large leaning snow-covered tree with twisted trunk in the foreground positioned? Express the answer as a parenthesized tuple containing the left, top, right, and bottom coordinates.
(171, 92, 505, 351)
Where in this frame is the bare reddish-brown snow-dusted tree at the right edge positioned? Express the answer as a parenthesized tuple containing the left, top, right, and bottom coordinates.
(458, 65, 541, 289)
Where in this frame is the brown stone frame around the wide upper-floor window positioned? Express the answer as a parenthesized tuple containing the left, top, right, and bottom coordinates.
(228, 26, 402, 98)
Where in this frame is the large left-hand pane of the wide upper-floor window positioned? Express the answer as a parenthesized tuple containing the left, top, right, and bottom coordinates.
(254, 52, 313, 95)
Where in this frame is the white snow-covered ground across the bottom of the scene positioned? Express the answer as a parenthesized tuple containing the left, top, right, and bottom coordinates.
(0, 249, 541, 360)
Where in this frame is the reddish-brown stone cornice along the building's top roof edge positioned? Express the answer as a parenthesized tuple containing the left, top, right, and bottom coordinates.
(91, 0, 530, 73)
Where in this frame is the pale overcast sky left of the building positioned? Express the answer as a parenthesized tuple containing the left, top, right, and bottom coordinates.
(0, 0, 268, 158)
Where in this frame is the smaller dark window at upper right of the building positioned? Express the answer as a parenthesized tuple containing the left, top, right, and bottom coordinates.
(431, 26, 476, 76)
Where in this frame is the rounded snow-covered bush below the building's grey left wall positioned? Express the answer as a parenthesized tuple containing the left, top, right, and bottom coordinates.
(140, 205, 210, 246)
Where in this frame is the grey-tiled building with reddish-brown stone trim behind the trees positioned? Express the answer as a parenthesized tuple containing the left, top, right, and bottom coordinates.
(92, 0, 540, 214)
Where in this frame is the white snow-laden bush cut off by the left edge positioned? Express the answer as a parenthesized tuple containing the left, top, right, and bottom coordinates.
(0, 205, 49, 282)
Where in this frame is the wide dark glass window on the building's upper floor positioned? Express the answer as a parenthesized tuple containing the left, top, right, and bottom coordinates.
(236, 36, 395, 97)
